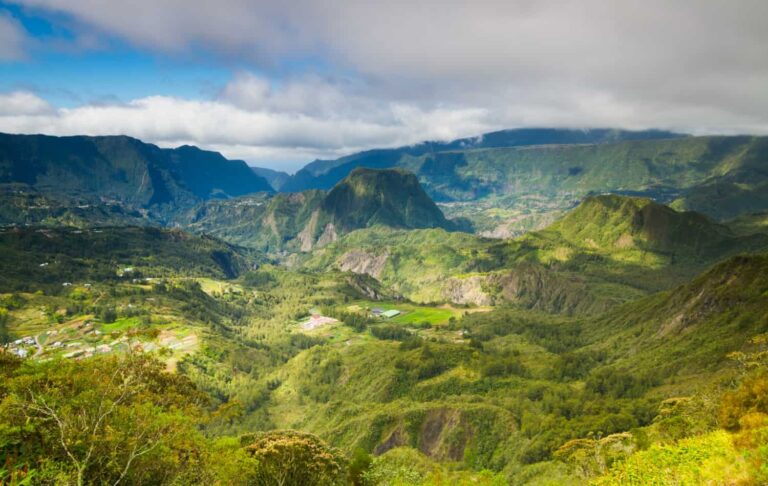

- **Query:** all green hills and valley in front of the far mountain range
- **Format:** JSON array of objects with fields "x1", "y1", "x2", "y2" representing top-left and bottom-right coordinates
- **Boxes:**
[{"x1": 0, "y1": 151, "x2": 768, "y2": 485}]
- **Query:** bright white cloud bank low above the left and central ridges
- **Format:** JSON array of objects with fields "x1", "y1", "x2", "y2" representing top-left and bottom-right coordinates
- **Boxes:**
[{"x1": 0, "y1": 84, "x2": 488, "y2": 170}]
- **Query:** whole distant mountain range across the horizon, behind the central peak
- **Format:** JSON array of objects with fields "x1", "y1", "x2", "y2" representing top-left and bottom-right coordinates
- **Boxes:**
[{"x1": 6, "y1": 129, "x2": 768, "y2": 243}]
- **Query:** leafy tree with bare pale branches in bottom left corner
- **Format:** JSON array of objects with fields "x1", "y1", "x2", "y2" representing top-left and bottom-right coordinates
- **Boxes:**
[{"x1": 0, "y1": 355, "x2": 210, "y2": 485}]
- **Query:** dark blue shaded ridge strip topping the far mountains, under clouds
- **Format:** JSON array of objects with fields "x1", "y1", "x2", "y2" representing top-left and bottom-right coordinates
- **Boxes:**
[{"x1": 283, "y1": 128, "x2": 685, "y2": 192}]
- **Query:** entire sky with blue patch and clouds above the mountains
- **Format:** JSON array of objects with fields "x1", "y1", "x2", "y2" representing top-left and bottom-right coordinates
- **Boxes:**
[{"x1": 0, "y1": 0, "x2": 768, "y2": 172}]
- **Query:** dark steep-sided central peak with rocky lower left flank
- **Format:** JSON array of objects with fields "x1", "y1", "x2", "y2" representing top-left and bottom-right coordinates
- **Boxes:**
[{"x1": 183, "y1": 169, "x2": 456, "y2": 252}]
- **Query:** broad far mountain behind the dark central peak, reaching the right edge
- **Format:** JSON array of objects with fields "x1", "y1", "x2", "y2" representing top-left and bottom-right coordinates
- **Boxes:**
[{"x1": 283, "y1": 131, "x2": 768, "y2": 237}]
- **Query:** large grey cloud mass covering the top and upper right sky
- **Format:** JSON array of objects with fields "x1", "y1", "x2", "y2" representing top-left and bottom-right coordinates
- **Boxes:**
[{"x1": 7, "y1": 0, "x2": 768, "y2": 139}]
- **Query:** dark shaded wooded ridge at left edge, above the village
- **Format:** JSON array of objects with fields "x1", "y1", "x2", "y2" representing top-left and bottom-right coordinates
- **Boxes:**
[{"x1": 0, "y1": 227, "x2": 259, "y2": 293}]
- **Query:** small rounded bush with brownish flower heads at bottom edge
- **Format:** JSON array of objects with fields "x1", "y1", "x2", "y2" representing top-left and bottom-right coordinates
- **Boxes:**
[{"x1": 243, "y1": 430, "x2": 346, "y2": 486}]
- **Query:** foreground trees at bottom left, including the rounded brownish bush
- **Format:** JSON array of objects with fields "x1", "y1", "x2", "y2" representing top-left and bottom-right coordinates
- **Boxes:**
[{"x1": 0, "y1": 355, "x2": 346, "y2": 485}]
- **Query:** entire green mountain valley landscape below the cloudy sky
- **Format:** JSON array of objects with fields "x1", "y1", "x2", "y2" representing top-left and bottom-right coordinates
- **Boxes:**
[{"x1": 0, "y1": 130, "x2": 768, "y2": 485}]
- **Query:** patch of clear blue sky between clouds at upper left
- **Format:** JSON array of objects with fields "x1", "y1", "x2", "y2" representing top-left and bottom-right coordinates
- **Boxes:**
[{"x1": 0, "y1": 2, "x2": 233, "y2": 107}]
